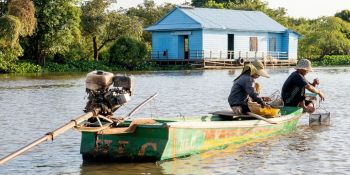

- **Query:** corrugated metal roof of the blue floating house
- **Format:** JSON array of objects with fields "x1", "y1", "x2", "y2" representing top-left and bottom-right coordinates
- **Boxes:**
[{"x1": 146, "y1": 7, "x2": 287, "y2": 32}]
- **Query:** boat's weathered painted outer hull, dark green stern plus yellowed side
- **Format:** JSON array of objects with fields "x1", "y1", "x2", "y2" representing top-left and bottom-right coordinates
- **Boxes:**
[{"x1": 81, "y1": 106, "x2": 302, "y2": 161}]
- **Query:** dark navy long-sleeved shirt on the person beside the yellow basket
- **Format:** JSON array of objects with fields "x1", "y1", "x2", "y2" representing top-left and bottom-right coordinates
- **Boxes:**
[{"x1": 228, "y1": 74, "x2": 263, "y2": 107}]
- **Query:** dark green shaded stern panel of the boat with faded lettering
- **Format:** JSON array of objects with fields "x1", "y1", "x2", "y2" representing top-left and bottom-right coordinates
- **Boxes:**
[{"x1": 80, "y1": 126, "x2": 168, "y2": 161}]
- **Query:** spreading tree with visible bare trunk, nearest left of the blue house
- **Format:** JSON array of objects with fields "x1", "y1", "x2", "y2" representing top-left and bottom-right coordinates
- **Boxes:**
[{"x1": 81, "y1": 0, "x2": 142, "y2": 60}]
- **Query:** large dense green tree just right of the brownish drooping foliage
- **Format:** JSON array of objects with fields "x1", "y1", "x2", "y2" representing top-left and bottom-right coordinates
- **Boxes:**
[{"x1": 23, "y1": 0, "x2": 80, "y2": 65}]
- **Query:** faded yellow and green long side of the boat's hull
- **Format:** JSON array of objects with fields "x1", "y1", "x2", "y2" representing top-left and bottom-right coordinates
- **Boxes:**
[{"x1": 161, "y1": 116, "x2": 298, "y2": 160}]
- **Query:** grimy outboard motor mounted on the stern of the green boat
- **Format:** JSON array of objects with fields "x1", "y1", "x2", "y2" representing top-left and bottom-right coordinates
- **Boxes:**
[{"x1": 84, "y1": 71, "x2": 134, "y2": 116}]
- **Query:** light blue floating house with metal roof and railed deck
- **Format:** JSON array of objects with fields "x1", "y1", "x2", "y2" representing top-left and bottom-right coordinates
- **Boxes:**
[{"x1": 146, "y1": 6, "x2": 300, "y2": 60}]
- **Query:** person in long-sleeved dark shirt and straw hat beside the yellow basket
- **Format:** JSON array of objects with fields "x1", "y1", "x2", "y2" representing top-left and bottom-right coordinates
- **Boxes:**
[{"x1": 228, "y1": 60, "x2": 269, "y2": 115}]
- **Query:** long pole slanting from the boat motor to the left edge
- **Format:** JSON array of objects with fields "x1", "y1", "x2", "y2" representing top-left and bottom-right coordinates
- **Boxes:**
[{"x1": 0, "y1": 108, "x2": 101, "y2": 165}]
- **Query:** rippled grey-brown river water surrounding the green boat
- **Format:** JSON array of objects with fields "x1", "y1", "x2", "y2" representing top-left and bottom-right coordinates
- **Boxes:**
[{"x1": 0, "y1": 67, "x2": 350, "y2": 175}]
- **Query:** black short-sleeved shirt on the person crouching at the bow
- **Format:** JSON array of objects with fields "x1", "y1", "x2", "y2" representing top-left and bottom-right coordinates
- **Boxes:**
[{"x1": 282, "y1": 71, "x2": 309, "y2": 106}]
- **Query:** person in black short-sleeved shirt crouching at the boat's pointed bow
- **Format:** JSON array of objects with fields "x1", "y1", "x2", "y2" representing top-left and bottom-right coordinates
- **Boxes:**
[{"x1": 282, "y1": 59, "x2": 325, "y2": 113}]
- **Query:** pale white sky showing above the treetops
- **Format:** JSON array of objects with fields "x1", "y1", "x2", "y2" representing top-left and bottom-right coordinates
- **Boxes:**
[{"x1": 113, "y1": 0, "x2": 350, "y2": 18}]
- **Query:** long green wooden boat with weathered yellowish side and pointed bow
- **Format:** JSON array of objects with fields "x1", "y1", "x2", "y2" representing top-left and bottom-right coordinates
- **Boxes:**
[{"x1": 80, "y1": 107, "x2": 302, "y2": 162}]
